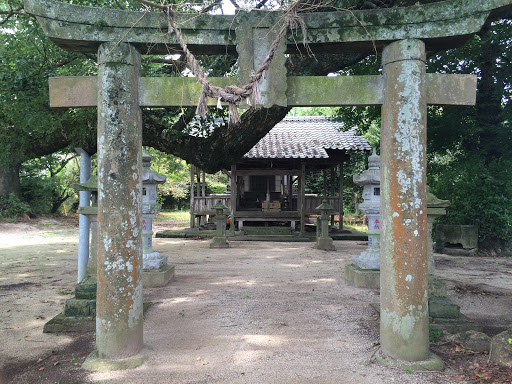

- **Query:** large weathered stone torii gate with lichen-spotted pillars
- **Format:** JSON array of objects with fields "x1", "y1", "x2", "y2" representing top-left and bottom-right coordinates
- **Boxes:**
[{"x1": 25, "y1": 0, "x2": 512, "y2": 369}]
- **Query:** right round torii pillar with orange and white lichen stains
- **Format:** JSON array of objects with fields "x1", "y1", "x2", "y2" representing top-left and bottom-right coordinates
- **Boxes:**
[{"x1": 380, "y1": 39, "x2": 442, "y2": 369}]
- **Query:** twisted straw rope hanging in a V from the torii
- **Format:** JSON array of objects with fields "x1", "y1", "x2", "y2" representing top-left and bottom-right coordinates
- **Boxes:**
[{"x1": 138, "y1": 0, "x2": 306, "y2": 124}]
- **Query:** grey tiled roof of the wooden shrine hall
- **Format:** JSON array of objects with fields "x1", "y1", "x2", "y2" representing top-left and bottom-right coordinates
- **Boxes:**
[{"x1": 244, "y1": 117, "x2": 371, "y2": 159}]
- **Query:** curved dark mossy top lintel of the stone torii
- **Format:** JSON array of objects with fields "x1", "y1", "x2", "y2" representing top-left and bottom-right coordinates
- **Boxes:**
[{"x1": 25, "y1": 0, "x2": 512, "y2": 54}]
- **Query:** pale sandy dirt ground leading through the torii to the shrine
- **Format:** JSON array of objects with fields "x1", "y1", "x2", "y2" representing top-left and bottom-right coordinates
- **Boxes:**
[{"x1": 0, "y1": 221, "x2": 512, "y2": 384}]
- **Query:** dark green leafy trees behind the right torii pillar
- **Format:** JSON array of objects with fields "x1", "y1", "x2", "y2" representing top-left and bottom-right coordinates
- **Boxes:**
[{"x1": 338, "y1": 14, "x2": 512, "y2": 249}]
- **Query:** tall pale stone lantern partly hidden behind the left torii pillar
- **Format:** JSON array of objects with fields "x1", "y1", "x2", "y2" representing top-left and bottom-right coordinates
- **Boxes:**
[{"x1": 142, "y1": 151, "x2": 174, "y2": 287}]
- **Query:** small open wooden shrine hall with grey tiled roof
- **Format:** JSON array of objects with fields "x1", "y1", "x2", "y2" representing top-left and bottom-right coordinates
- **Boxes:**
[{"x1": 190, "y1": 117, "x2": 371, "y2": 232}]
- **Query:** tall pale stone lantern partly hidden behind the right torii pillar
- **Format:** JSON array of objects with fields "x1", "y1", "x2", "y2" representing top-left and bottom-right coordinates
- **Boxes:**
[{"x1": 353, "y1": 148, "x2": 380, "y2": 269}]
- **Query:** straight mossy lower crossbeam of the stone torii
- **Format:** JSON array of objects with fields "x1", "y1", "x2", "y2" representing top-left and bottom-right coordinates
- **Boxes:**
[{"x1": 49, "y1": 73, "x2": 476, "y2": 108}]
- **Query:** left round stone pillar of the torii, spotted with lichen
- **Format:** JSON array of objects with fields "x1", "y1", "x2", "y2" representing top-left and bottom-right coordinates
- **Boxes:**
[{"x1": 84, "y1": 42, "x2": 143, "y2": 370}]
